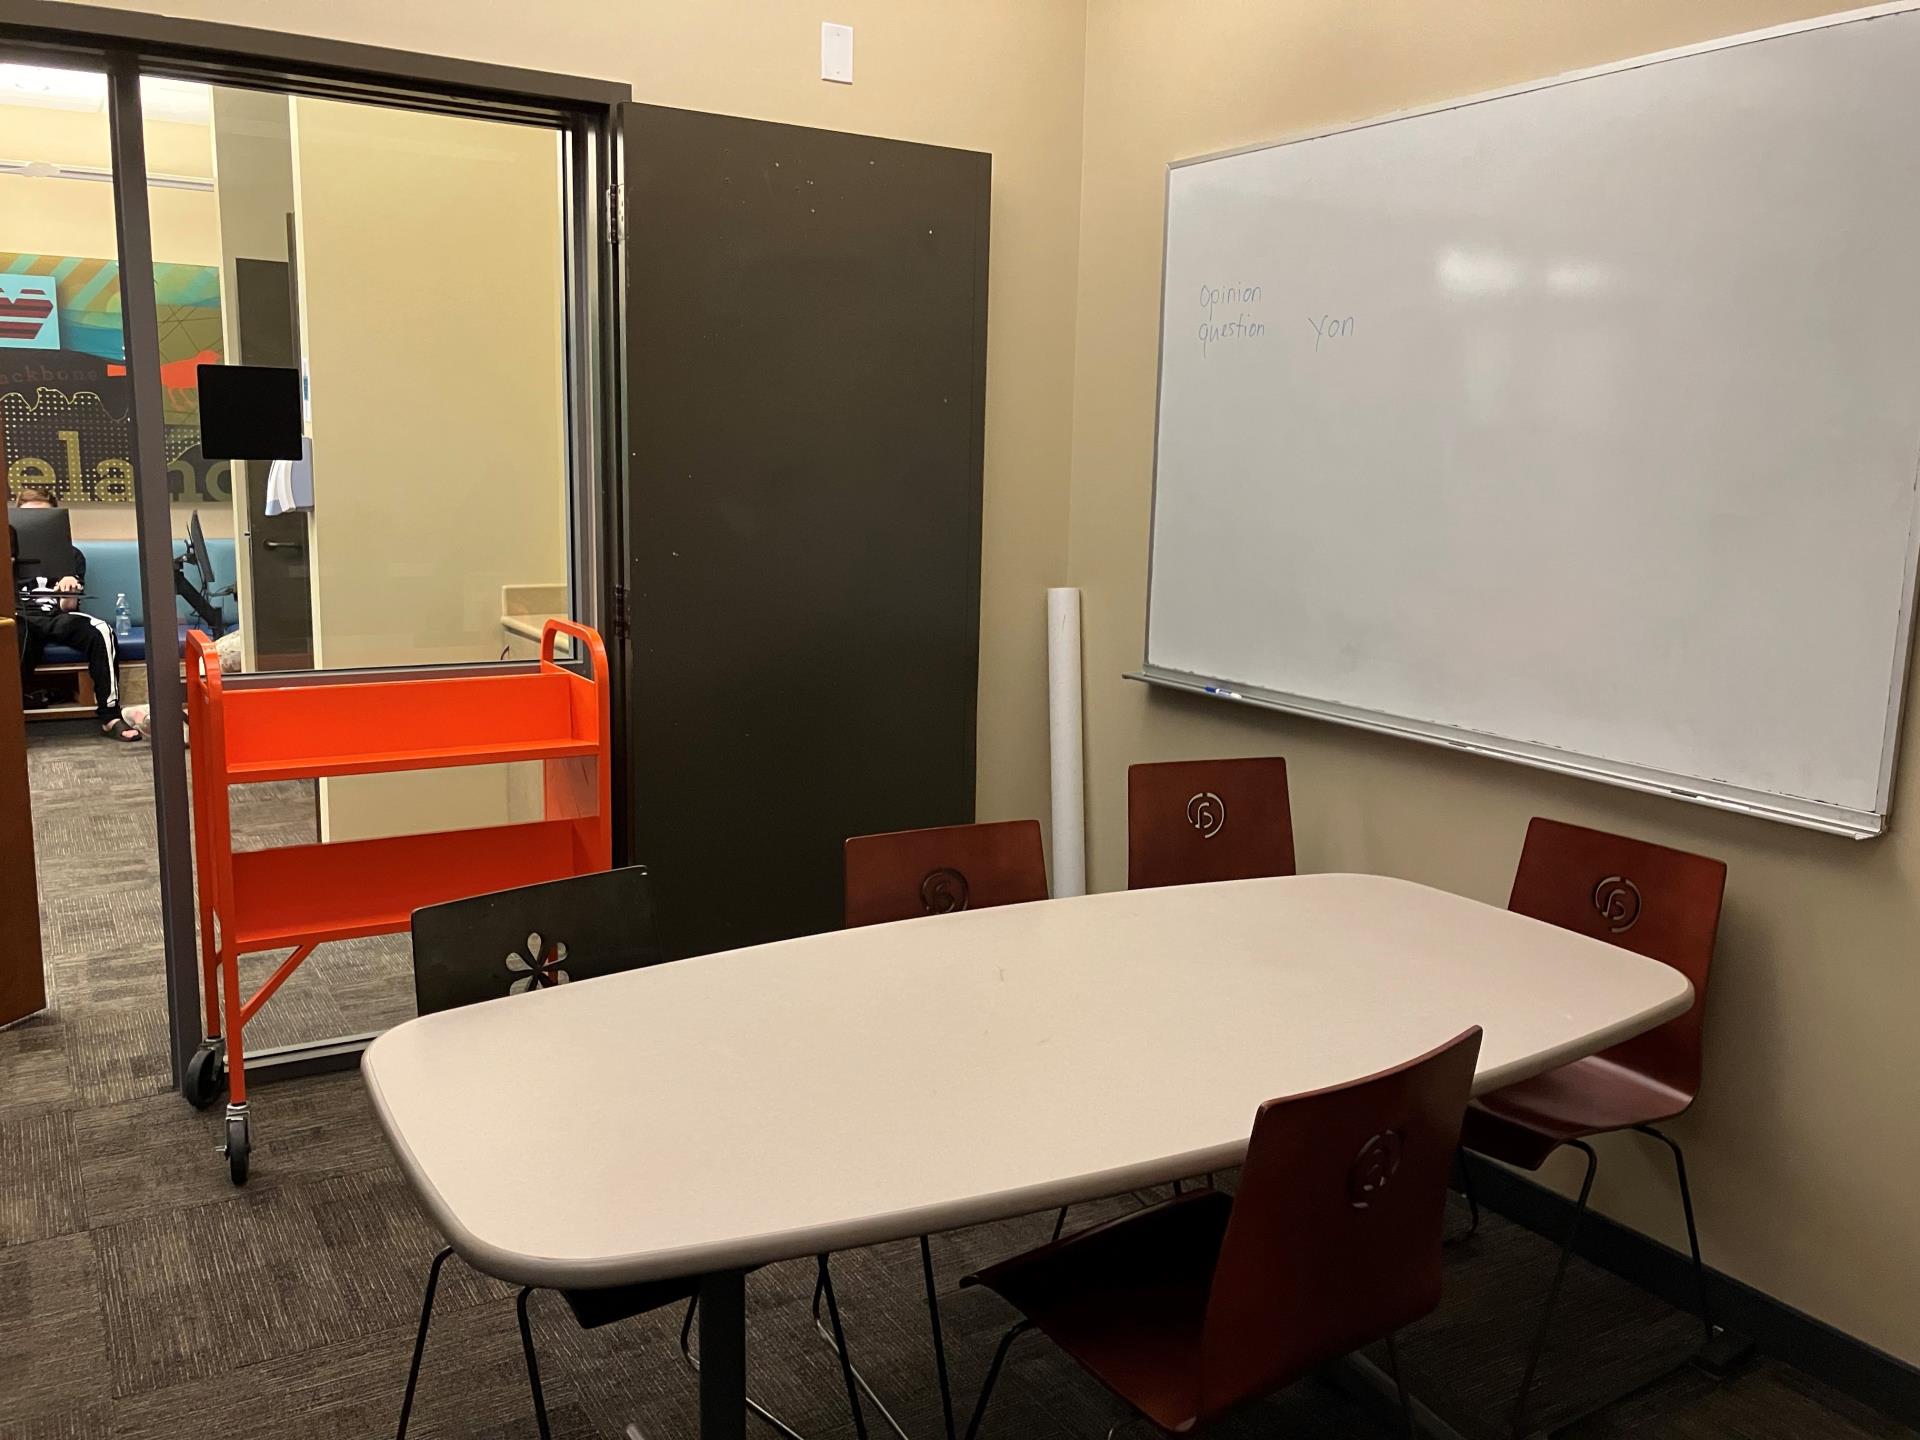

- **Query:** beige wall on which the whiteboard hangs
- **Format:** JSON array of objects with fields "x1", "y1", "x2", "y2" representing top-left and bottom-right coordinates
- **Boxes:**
[{"x1": 1069, "y1": 0, "x2": 1920, "y2": 1361}]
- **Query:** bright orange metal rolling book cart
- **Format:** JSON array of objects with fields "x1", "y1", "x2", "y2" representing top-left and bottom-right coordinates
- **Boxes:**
[{"x1": 186, "y1": 620, "x2": 612, "y2": 1185}]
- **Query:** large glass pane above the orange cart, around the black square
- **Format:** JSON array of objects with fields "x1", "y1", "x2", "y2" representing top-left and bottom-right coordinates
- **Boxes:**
[{"x1": 157, "y1": 81, "x2": 574, "y2": 683}]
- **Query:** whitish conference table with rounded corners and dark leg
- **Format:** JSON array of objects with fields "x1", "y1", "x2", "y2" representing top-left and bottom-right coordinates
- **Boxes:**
[{"x1": 361, "y1": 876, "x2": 1692, "y2": 1440}]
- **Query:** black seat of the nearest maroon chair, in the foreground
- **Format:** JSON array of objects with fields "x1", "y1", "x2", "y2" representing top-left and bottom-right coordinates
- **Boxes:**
[{"x1": 964, "y1": 1190, "x2": 1233, "y2": 1434}]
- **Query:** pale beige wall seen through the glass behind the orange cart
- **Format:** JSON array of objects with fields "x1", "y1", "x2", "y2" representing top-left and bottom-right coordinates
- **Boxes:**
[{"x1": 292, "y1": 100, "x2": 568, "y2": 839}]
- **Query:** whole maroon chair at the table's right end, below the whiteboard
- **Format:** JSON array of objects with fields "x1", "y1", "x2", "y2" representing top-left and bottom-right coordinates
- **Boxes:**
[{"x1": 1461, "y1": 818, "x2": 1726, "y2": 1436}]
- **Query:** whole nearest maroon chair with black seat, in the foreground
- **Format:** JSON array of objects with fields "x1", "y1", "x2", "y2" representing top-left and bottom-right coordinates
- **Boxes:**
[{"x1": 968, "y1": 1027, "x2": 1480, "y2": 1440}]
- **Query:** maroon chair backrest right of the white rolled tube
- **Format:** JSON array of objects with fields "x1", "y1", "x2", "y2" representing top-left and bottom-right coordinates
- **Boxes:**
[{"x1": 1127, "y1": 755, "x2": 1294, "y2": 891}]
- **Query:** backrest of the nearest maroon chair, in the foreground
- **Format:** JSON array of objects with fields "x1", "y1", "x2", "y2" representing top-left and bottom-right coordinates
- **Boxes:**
[{"x1": 1200, "y1": 1025, "x2": 1480, "y2": 1419}]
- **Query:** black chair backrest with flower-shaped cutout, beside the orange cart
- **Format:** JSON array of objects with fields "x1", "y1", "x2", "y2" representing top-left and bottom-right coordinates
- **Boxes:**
[{"x1": 413, "y1": 866, "x2": 666, "y2": 1016}]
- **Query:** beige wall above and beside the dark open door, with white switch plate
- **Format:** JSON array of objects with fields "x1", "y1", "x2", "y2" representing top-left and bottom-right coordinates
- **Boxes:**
[{"x1": 90, "y1": 0, "x2": 1085, "y2": 844}]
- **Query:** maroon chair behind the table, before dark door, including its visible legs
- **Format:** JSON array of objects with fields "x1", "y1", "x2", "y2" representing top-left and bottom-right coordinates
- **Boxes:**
[{"x1": 814, "y1": 820, "x2": 1066, "y2": 1440}]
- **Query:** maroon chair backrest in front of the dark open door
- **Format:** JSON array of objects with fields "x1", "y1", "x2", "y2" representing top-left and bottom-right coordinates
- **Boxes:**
[{"x1": 847, "y1": 820, "x2": 1046, "y2": 925}]
